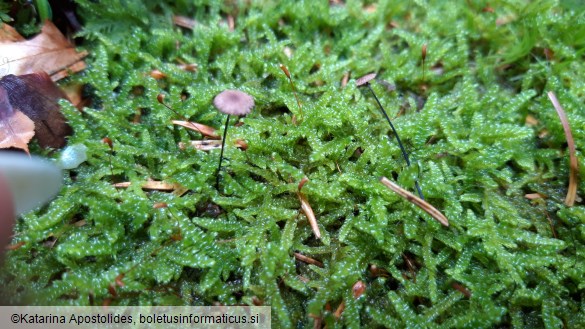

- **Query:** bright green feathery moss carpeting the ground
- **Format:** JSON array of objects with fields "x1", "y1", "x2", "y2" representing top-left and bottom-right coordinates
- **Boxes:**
[{"x1": 2, "y1": 0, "x2": 585, "y2": 328}]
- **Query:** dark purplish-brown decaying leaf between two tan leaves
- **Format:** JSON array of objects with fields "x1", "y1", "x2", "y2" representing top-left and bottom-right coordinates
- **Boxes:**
[{"x1": 0, "y1": 72, "x2": 71, "y2": 148}]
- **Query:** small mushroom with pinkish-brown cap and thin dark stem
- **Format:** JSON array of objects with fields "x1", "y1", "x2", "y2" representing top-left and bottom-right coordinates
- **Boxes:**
[{"x1": 213, "y1": 89, "x2": 254, "y2": 189}]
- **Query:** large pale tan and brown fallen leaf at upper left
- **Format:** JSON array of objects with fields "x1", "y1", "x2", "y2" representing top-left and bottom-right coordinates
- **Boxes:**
[{"x1": 0, "y1": 21, "x2": 87, "y2": 81}]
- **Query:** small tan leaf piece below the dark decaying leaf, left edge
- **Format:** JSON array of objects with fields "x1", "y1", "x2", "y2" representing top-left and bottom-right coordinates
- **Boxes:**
[{"x1": 0, "y1": 88, "x2": 35, "y2": 153}]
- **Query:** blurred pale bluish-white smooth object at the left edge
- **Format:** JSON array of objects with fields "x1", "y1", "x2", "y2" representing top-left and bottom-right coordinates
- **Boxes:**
[{"x1": 0, "y1": 152, "x2": 62, "y2": 216}]
